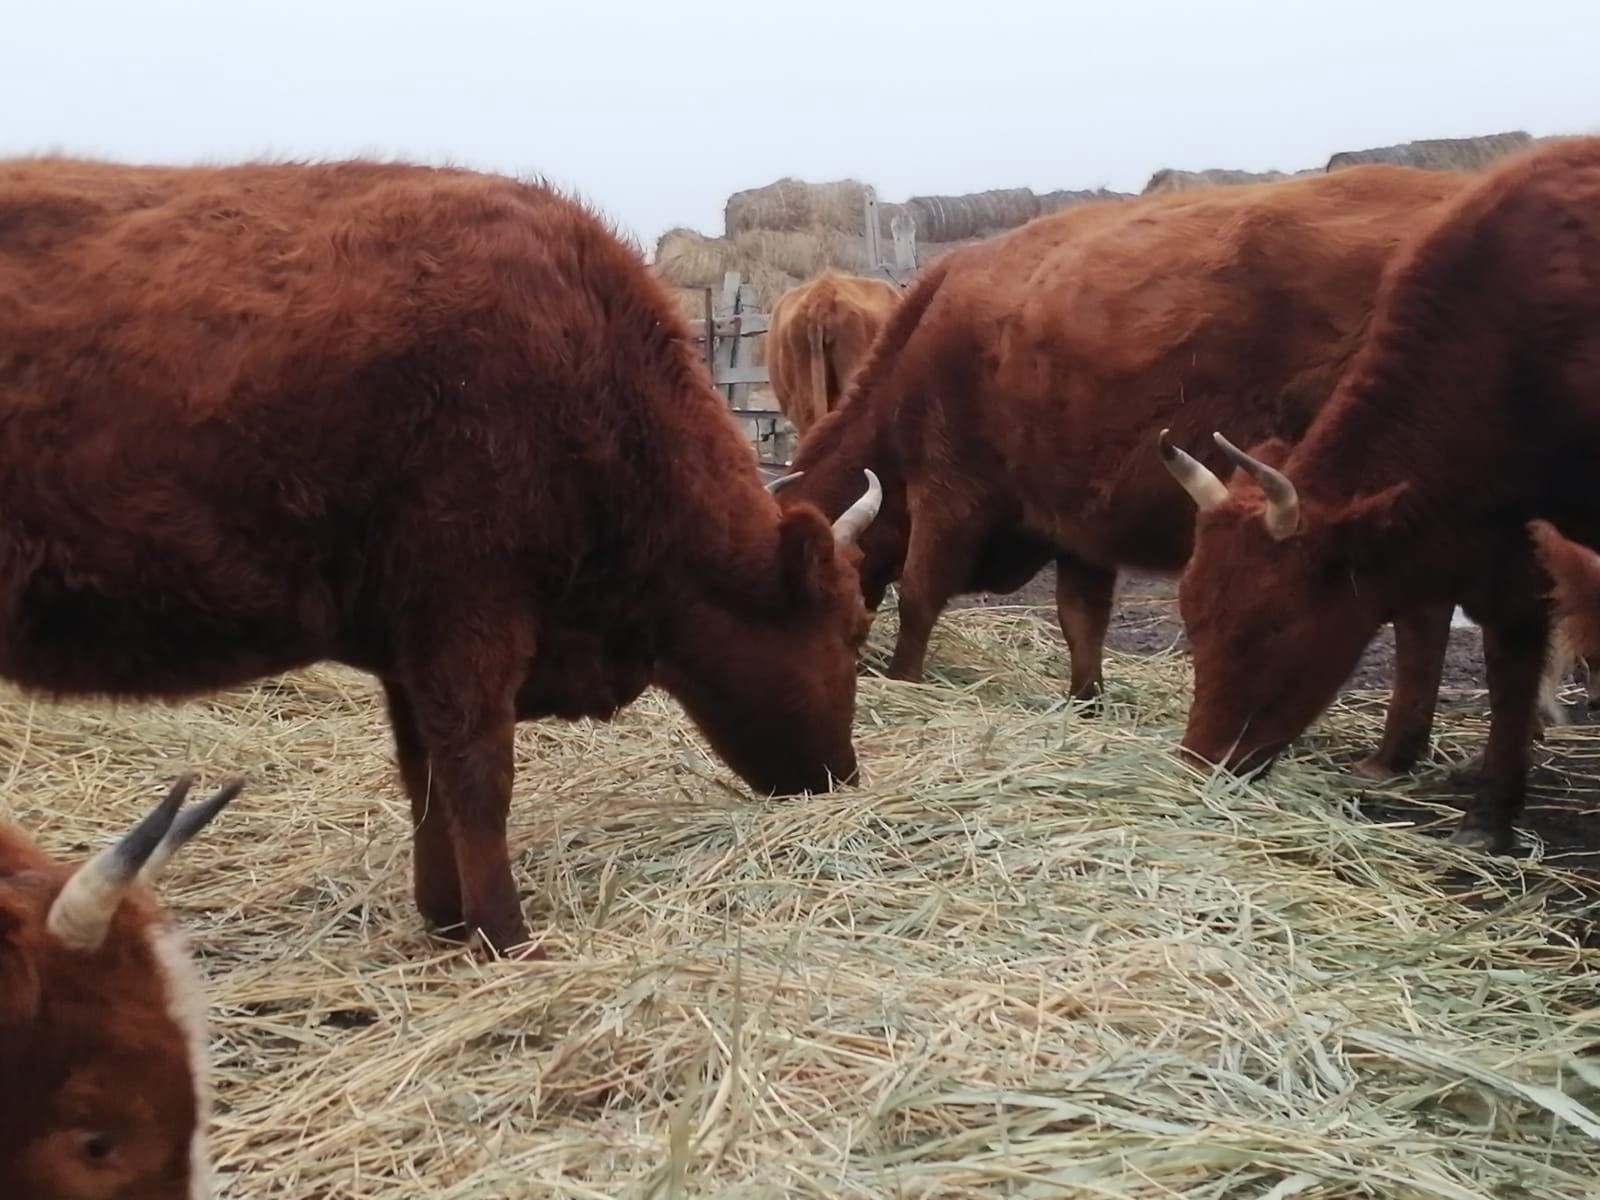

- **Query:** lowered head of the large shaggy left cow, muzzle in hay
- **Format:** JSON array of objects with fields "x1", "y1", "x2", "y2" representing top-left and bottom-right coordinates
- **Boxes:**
[{"x1": 658, "y1": 470, "x2": 883, "y2": 795}]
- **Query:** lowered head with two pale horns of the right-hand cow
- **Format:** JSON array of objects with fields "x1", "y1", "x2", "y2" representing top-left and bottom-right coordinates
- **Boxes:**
[{"x1": 1160, "y1": 429, "x2": 1397, "y2": 771}]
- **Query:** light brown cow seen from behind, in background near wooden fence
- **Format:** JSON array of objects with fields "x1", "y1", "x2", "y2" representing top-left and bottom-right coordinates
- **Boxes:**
[{"x1": 766, "y1": 270, "x2": 901, "y2": 437}]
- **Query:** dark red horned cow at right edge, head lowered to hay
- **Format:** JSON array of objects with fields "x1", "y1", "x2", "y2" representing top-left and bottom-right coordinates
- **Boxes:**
[{"x1": 1152, "y1": 139, "x2": 1600, "y2": 850}]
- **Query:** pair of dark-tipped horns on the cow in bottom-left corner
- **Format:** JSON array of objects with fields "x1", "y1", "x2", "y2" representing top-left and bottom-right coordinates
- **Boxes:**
[{"x1": 45, "y1": 774, "x2": 243, "y2": 952}]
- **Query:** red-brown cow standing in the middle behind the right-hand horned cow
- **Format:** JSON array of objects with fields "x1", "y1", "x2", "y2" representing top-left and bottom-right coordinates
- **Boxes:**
[{"x1": 782, "y1": 166, "x2": 1467, "y2": 774}]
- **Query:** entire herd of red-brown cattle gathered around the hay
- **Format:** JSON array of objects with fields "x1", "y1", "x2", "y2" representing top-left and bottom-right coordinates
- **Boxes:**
[{"x1": 0, "y1": 139, "x2": 1600, "y2": 1200}]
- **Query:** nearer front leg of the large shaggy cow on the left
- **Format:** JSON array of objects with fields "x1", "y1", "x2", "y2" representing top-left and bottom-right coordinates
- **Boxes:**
[{"x1": 406, "y1": 637, "x2": 531, "y2": 955}]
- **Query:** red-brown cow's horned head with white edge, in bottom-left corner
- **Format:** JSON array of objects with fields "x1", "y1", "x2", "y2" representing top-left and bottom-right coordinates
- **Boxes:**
[{"x1": 0, "y1": 776, "x2": 243, "y2": 1200}]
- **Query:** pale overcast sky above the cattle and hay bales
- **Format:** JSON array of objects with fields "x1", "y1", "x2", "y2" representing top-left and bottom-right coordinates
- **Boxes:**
[{"x1": 0, "y1": 0, "x2": 1600, "y2": 256}]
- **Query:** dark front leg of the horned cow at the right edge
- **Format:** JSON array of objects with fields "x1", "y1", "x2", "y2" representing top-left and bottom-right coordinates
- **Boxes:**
[{"x1": 1450, "y1": 619, "x2": 1546, "y2": 853}]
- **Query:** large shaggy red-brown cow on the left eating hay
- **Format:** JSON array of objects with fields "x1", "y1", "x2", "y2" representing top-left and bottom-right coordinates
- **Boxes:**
[{"x1": 0, "y1": 158, "x2": 877, "y2": 950}]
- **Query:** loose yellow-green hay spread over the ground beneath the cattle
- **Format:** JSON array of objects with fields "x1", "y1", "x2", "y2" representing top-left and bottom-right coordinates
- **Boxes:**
[{"x1": 9, "y1": 611, "x2": 1600, "y2": 1200}]
